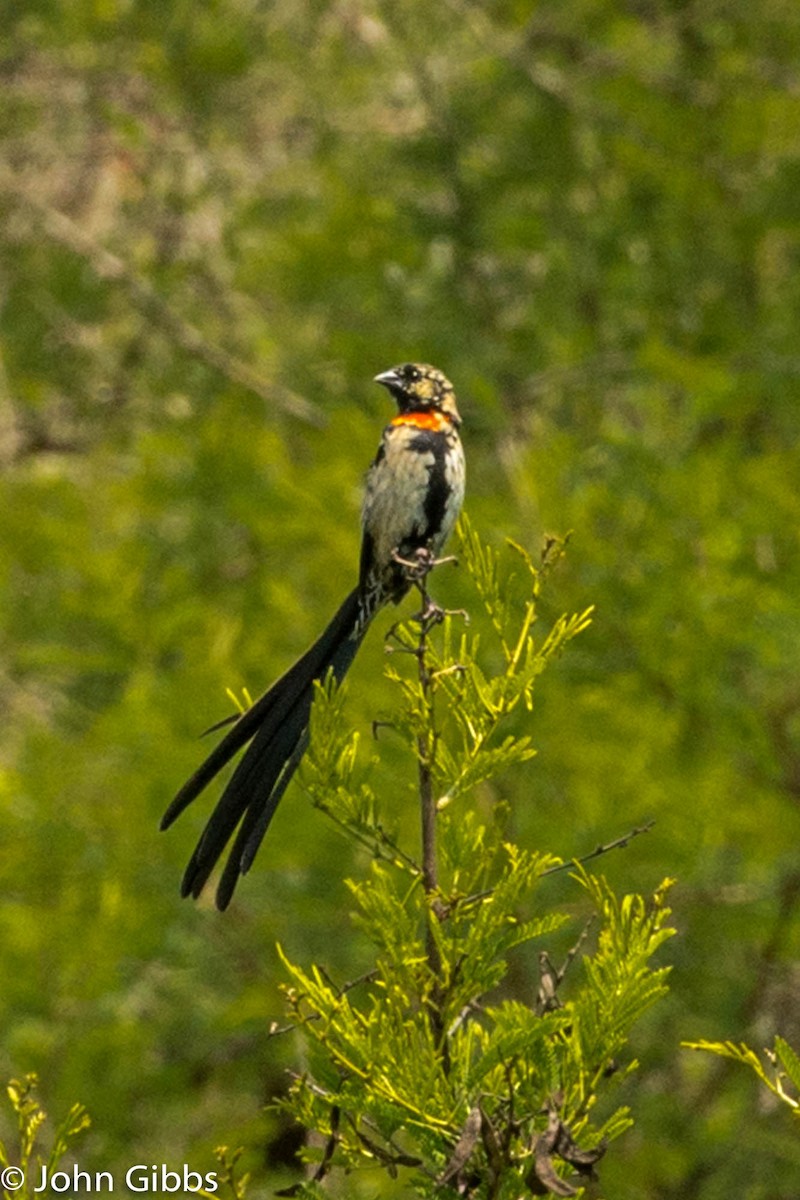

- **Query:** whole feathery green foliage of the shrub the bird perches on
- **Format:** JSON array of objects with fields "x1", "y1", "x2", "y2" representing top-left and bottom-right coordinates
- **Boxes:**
[{"x1": 281, "y1": 542, "x2": 673, "y2": 1198}]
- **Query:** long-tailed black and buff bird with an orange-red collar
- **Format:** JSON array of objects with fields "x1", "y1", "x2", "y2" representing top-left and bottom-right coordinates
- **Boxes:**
[{"x1": 161, "y1": 362, "x2": 465, "y2": 911}]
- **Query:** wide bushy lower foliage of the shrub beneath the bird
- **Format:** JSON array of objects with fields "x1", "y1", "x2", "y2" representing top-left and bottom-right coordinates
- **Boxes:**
[{"x1": 282, "y1": 844, "x2": 672, "y2": 1196}]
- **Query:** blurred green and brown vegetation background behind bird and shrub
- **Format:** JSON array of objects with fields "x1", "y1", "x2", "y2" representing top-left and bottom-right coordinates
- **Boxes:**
[{"x1": 0, "y1": 0, "x2": 800, "y2": 1200}]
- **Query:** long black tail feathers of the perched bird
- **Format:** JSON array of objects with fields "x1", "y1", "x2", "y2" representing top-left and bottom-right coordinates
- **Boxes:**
[{"x1": 161, "y1": 588, "x2": 368, "y2": 908}]
